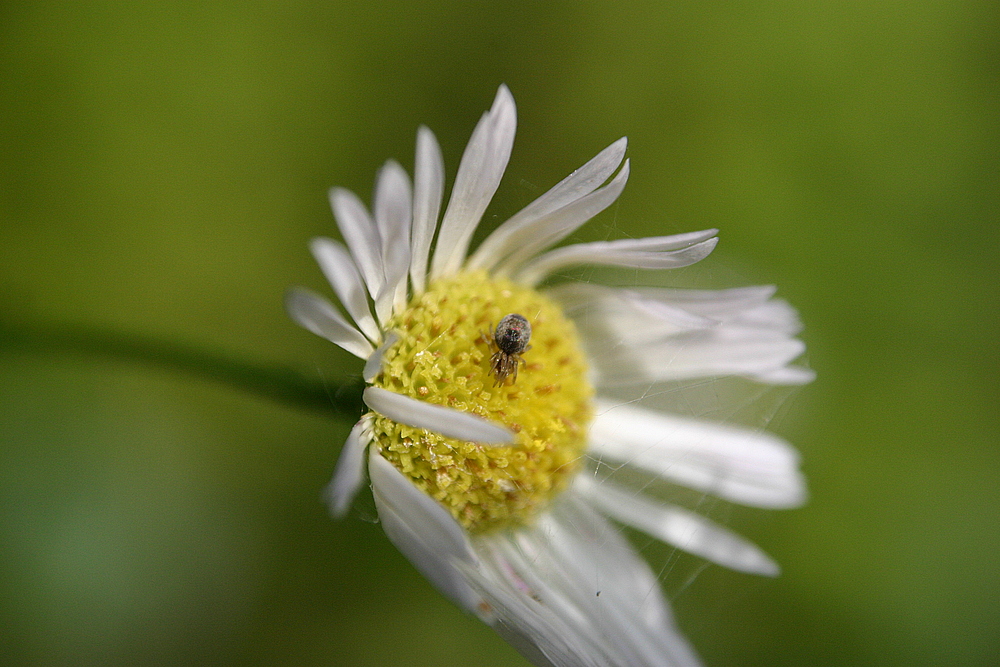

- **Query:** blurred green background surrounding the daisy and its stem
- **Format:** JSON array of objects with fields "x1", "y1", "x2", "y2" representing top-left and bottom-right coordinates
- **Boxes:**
[{"x1": 0, "y1": 0, "x2": 1000, "y2": 667}]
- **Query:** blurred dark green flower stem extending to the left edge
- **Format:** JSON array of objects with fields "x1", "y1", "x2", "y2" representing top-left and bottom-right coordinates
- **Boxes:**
[{"x1": 0, "y1": 317, "x2": 364, "y2": 419}]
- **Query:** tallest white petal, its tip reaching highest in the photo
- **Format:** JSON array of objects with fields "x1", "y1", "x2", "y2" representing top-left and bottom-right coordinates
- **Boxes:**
[{"x1": 431, "y1": 86, "x2": 517, "y2": 278}]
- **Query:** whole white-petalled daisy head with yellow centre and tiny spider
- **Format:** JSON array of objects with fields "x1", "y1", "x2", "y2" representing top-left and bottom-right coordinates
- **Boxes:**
[{"x1": 286, "y1": 86, "x2": 812, "y2": 667}]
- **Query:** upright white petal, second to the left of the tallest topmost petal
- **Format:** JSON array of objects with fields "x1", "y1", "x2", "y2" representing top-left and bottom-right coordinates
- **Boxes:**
[{"x1": 374, "y1": 160, "x2": 413, "y2": 324}]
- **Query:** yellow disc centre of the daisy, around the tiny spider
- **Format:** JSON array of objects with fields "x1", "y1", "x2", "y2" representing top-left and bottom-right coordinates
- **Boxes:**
[{"x1": 372, "y1": 272, "x2": 593, "y2": 533}]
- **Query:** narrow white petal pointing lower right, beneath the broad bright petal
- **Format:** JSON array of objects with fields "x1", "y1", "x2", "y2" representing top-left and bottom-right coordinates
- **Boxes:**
[{"x1": 576, "y1": 475, "x2": 780, "y2": 577}]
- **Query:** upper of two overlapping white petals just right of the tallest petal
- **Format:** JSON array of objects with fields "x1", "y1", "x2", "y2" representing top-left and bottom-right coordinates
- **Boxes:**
[{"x1": 469, "y1": 137, "x2": 628, "y2": 270}]
